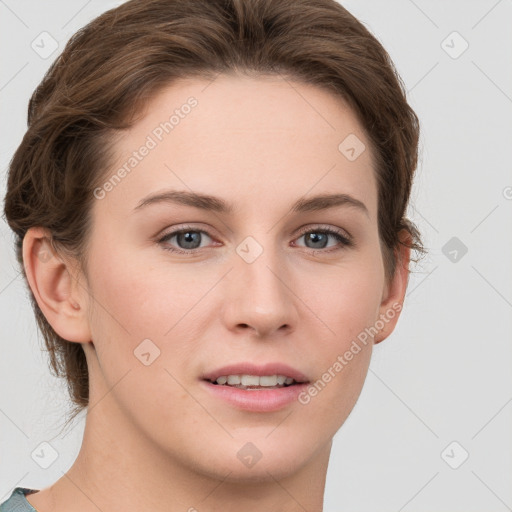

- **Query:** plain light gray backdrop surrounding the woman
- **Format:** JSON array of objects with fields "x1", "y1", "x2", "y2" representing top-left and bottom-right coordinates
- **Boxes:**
[{"x1": 0, "y1": 0, "x2": 512, "y2": 512}]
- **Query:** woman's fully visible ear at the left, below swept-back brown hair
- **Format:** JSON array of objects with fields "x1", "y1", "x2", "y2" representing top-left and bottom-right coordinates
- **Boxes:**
[{"x1": 23, "y1": 227, "x2": 91, "y2": 343}]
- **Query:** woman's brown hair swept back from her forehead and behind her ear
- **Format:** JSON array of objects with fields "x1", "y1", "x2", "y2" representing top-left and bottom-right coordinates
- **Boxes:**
[{"x1": 5, "y1": 0, "x2": 425, "y2": 426}]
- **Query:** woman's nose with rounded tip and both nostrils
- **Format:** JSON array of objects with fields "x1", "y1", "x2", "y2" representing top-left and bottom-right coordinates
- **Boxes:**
[{"x1": 222, "y1": 243, "x2": 299, "y2": 338}]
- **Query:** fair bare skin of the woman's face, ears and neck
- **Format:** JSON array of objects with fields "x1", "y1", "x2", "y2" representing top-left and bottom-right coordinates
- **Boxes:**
[{"x1": 23, "y1": 75, "x2": 409, "y2": 512}]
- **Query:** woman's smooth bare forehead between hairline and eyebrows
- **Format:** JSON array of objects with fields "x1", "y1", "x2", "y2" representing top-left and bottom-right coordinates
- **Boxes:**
[{"x1": 96, "y1": 75, "x2": 376, "y2": 220}]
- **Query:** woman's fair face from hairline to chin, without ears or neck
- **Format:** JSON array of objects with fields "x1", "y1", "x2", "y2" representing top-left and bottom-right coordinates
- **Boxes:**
[{"x1": 69, "y1": 75, "x2": 404, "y2": 479}]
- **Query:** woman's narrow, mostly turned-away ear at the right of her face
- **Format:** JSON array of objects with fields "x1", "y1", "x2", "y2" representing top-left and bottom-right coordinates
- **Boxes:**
[{"x1": 374, "y1": 230, "x2": 411, "y2": 345}]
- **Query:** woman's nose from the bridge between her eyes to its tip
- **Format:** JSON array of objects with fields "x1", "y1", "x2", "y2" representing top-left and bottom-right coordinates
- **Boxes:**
[{"x1": 226, "y1": 234, "x2": 297, "y2": 335}]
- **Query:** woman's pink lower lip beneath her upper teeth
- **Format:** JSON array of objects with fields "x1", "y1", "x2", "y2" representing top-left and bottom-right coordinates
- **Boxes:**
[{"x1": 202, "y1": 380, "x2": 307, "y2": 412}]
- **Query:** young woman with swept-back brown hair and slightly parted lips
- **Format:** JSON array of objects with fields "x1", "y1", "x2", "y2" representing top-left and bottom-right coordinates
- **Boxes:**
[{"x1": 2, "y1": 0, "x2": 422, "y2": 512}]
